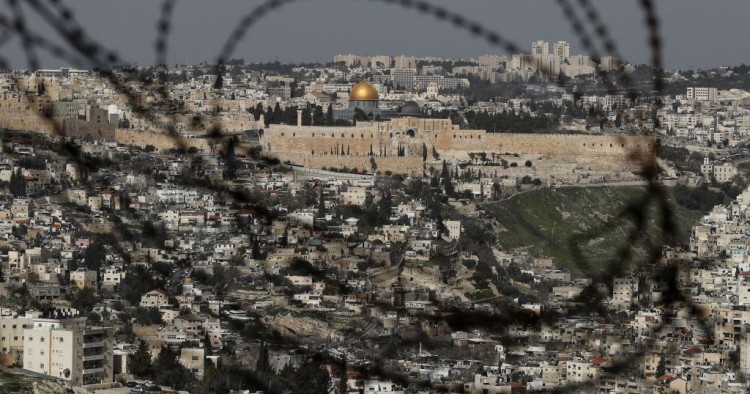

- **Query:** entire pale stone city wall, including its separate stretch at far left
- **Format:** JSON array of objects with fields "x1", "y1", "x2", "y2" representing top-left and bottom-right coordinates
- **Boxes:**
[{"x1": 0, "y1": 107, "x2": 656, "y2": 174}]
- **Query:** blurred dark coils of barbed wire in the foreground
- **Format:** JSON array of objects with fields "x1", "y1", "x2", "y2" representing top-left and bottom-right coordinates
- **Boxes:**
[{"x1": 0, "y1": 0, "x2": 716, "y2": 391}]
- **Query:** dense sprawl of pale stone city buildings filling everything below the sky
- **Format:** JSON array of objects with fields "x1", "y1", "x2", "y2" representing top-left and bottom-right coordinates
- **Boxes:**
[{"x1": 0, "y1": 41, "x2": 750, "y2": 393}]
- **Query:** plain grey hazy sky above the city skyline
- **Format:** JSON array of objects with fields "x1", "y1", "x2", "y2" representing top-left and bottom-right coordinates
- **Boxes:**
[{"x1": 5, "y1": 0, "x2": 750, "y2": 69}]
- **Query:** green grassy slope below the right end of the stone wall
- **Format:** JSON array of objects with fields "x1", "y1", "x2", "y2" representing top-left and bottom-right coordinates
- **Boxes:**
[{"x1": 483, "y1": 186, "x2": 705, "y2": 272}]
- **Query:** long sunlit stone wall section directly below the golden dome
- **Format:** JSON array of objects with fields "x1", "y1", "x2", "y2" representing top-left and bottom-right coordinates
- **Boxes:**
[{"x1": 261, "y1": 118, "x2": 656, "y2": 173}]
